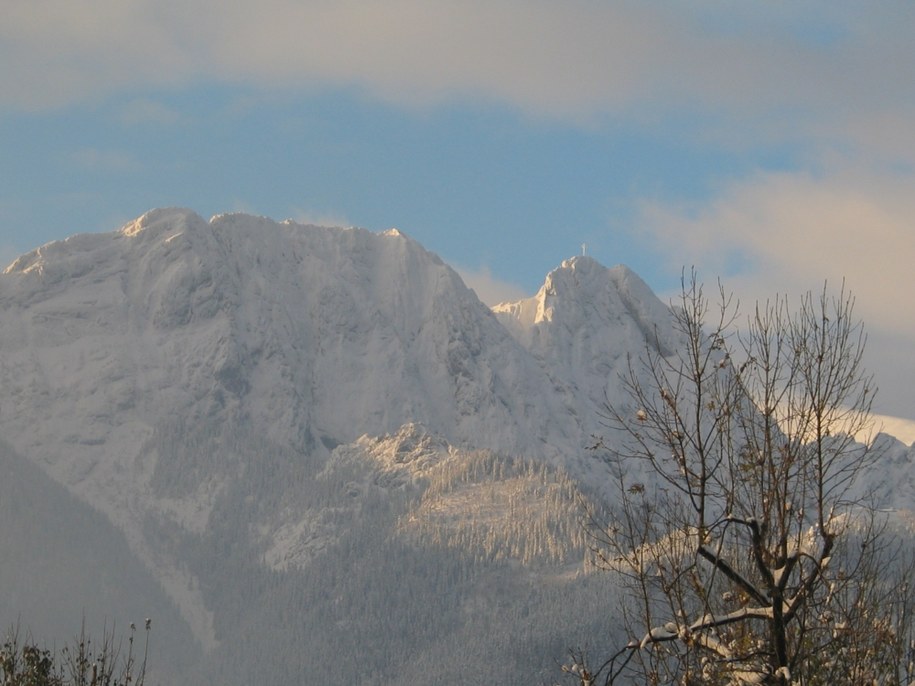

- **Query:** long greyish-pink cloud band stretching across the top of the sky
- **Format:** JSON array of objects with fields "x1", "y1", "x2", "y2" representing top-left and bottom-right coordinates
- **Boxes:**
[{"x1": 0, "y1": 0, "x2": 915, "y2": 146}]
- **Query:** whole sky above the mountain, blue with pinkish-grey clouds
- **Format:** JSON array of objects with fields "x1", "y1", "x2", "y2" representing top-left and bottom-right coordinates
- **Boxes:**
[{"x1": 0, "y1": 0, "x2": 915, "y2": 418}]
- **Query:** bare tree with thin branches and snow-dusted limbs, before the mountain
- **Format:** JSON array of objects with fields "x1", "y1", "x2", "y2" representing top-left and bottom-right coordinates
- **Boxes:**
[{"x1": 564, "y1": 275, "x2": 915, "y2": 685}]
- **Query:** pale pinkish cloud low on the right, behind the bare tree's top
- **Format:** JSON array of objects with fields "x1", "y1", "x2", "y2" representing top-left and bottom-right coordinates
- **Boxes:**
[{"x1": 637, "y1": 164, "x2": 915, "y2": 416}]
